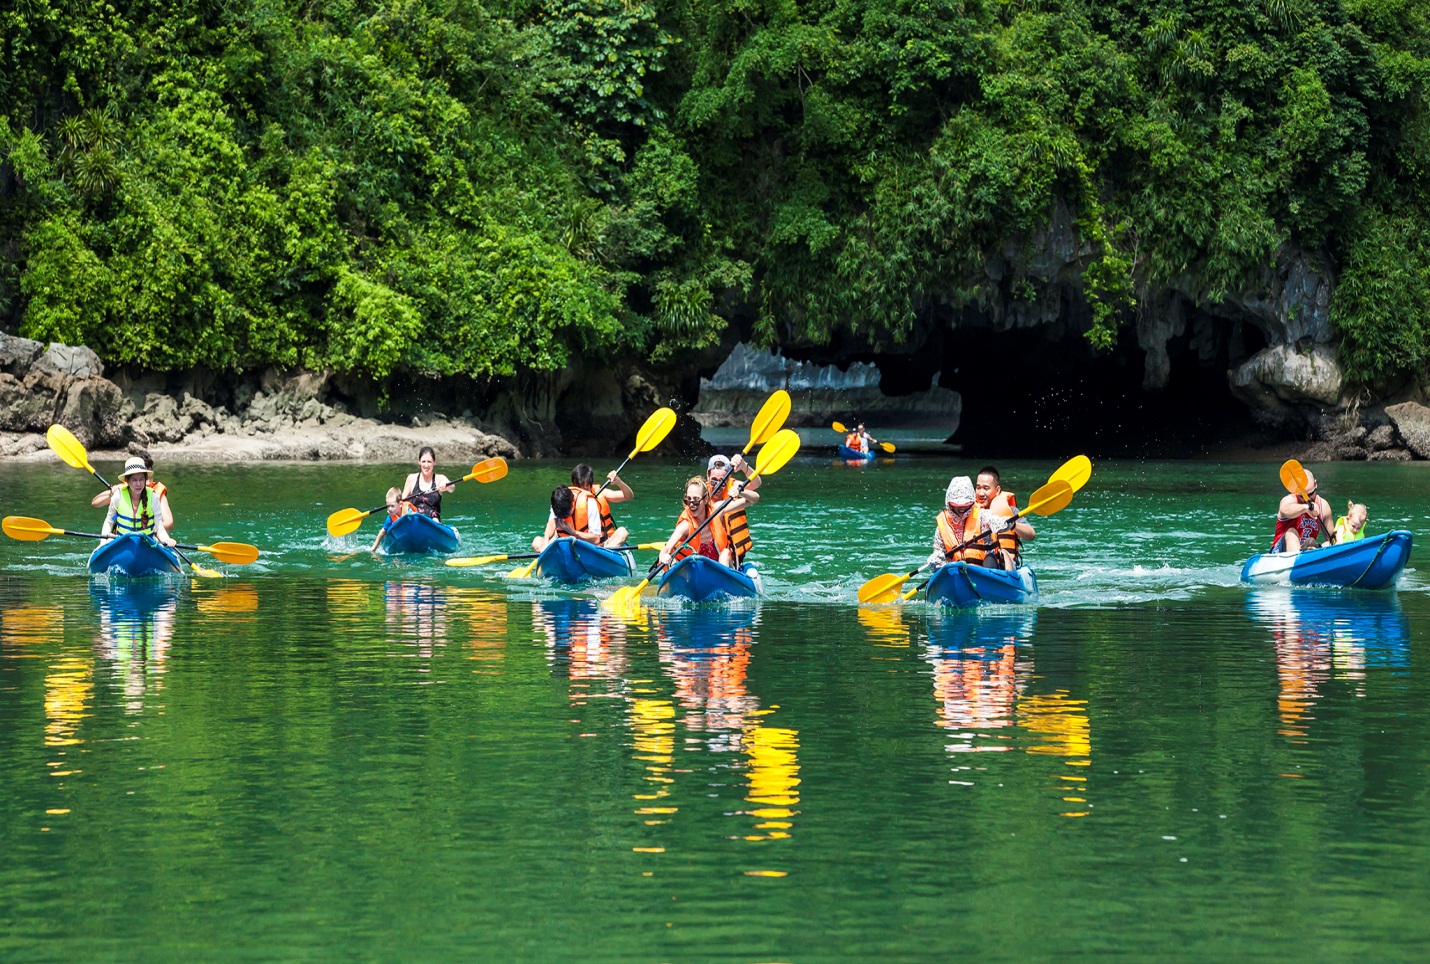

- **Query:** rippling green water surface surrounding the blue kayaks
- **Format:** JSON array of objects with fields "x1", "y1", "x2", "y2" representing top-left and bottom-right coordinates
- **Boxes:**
[{"x1": 0, "y1": 456, "x2": 1430, "y2": 961}]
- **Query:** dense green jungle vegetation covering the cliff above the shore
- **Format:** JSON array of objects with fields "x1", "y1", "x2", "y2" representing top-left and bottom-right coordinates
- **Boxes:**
[{"x1": 0, "y1": 0, "x2": 1430, "y2": 382}]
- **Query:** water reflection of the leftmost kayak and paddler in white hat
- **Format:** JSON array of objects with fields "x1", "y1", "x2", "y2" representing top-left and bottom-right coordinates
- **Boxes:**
[{"x1": 90, "y1": 578, "x2": 182, "y2": 714}]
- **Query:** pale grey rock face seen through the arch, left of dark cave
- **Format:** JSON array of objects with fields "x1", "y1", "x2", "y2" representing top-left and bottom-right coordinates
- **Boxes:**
[{"x1": 691, "y1": 343, "x2": 962, "y2": 433}]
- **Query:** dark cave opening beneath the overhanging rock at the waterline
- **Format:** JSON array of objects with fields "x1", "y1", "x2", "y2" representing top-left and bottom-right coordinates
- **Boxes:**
[{"x1": 879, "y1": 320, "x2": 1278, "y2": 458}]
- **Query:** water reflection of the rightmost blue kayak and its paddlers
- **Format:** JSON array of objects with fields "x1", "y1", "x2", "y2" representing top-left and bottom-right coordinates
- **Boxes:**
[{"x1": 1247, "y1": 588, "x2": 1410, "y2": 744}]
